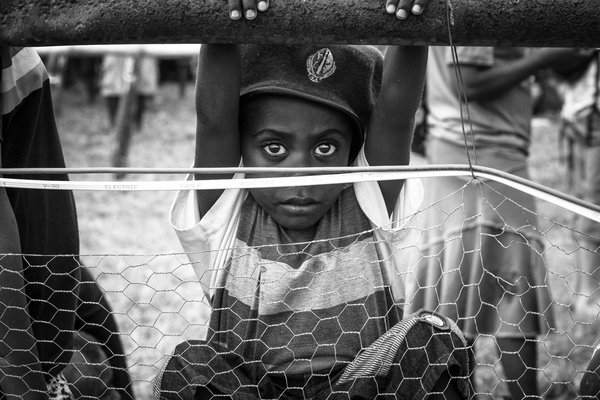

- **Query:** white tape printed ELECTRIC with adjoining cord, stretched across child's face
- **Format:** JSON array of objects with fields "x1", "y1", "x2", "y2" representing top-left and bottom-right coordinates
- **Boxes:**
[{"x1": 0, "y1": 165, "x2": 600, "y2": 222}]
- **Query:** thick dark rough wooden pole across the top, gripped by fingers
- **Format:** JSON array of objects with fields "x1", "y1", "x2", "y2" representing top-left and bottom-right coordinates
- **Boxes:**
[{"x1": 0, "y1": 0, "x2": 600, "y2": 47}]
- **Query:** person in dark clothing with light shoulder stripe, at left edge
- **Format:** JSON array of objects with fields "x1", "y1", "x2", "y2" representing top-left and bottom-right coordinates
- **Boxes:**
[{"x1": 0, "y1": 46, "x2": 80, "y2": 400}]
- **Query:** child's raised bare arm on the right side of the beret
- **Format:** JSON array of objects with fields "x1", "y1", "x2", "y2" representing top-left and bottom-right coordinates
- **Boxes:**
[{"x1": 365, "y1": 46, "x2": 427, "y2": 213}]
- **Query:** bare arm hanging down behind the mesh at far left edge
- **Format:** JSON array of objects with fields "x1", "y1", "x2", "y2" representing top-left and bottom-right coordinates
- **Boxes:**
[{"x1": 0, "y1": 170, "x2": 48, "y2": 400}]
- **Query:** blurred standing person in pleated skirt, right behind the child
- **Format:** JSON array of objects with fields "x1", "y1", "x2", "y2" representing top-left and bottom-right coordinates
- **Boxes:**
[{"x1": 407, "y1": 47, "x2": 580, "y2": 400}]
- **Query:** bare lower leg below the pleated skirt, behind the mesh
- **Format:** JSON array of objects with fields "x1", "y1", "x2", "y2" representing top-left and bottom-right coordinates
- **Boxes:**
[{"x1": 496, "y1": 338, "x2": 539, "y2": 400}]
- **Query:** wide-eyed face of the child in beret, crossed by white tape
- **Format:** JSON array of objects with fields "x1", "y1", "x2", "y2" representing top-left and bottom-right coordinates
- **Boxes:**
[{"x1": 240, "y1": 95, "x2": 354, "y2": 230}]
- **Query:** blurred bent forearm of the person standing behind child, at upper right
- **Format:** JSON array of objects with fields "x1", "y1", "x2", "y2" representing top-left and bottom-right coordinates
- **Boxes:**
[{"x1": 451, "y1": 48, "x2": 578, "y2": 101}]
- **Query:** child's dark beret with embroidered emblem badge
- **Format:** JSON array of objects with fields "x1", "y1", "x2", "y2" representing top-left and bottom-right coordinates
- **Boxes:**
[{"x1": 240, "y1": 44, "x2": 383, "y2": 159}]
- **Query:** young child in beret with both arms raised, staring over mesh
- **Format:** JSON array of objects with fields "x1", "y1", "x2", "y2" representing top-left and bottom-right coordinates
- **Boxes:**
[{"x1": 155, "y1": 3, "x2": 469, "y2": 399}]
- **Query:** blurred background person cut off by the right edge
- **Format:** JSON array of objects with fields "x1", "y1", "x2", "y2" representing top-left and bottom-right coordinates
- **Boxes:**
[{"x1": 553, "y1": 49, "x2": 600, "y2": 322}]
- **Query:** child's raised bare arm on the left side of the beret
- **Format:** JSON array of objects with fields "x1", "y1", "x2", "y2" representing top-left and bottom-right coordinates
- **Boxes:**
[{"x1": 194, "y1": 44, "x2": 241, "y2": 215}]
